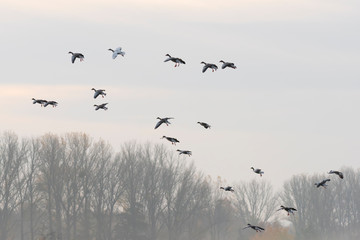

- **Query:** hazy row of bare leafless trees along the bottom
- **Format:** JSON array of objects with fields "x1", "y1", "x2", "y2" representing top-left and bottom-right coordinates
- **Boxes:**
[{"x1": 0, "y1": 132, "x2": 360, "y2": 240}]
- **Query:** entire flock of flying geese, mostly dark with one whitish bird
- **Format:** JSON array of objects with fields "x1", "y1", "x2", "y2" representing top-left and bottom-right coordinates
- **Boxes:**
[{"x1": 32, "y1": 47, "x2": 344, "y2": 232}]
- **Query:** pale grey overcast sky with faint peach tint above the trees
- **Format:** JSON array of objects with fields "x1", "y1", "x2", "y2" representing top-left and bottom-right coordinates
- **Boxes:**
[{"x1": 0, "y1": 0, "x2": 360, "y2": 187}]
